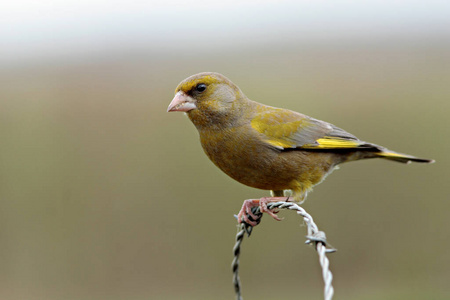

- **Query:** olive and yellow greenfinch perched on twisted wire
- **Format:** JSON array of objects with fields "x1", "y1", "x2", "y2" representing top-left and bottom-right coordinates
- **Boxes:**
[{"x1": 167, "y1": 72, "x2": 434, "y2": 226}]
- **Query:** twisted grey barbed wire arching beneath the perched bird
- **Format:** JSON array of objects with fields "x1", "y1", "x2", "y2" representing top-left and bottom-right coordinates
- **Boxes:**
[{"x1": 231, "y1": 201, "x2": 336, "y2": 300}]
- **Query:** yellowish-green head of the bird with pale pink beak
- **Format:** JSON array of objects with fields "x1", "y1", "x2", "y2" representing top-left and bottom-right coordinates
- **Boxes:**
[{"x1": 167, "y1": 72, "x2": 245, "y2": 128}]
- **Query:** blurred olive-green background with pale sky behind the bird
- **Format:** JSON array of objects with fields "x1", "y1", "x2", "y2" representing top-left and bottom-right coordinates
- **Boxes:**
[{"x1": 0, "y1": 0, "x2": 450, "y2": 300}]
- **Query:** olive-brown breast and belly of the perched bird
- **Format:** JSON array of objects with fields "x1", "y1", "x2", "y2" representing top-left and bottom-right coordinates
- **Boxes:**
[{"x1": 200, "y1": 128, "x2": 332, "y2": 190}]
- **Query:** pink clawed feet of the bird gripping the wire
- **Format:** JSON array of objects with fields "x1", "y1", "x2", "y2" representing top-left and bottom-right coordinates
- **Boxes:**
[{"x1": 237, "y1": 197, "x2": 286, "y2": 226}]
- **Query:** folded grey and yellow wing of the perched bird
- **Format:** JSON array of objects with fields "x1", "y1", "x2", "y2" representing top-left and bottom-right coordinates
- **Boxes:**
[{"x1": 251, "y1": 107, "x2": 375, "y2": 150}]
